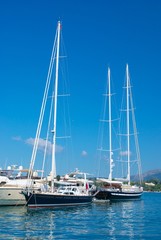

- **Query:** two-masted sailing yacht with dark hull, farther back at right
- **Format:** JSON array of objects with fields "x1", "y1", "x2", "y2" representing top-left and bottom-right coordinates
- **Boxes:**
[{"x1": 95, "y1": 65, "x2": 143, "y2": 201}]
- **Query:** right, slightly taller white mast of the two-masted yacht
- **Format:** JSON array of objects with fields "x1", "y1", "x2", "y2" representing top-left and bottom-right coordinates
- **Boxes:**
[{"x1": 126, "y1": 64, "x2": 130, "y2": 184}]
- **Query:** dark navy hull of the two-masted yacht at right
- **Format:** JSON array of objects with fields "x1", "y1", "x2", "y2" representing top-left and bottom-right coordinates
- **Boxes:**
[{"x1": 95, "y1": 190, "x2": 143, "y2": 201}]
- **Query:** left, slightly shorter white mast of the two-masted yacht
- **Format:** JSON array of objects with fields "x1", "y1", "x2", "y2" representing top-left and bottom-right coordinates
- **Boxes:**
[{"x1": 108, "y1": 68, "x2": 113, "y2": 181}]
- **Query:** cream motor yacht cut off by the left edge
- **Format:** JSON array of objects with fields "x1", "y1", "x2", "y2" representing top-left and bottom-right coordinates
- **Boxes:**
[{"x1": 0, "y1": 165, "x2": 44, "y2": 206}]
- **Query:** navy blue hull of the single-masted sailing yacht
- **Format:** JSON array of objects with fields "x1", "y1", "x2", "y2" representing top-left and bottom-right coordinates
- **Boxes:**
[{"x1": 23, "y1": 193, "x2": 93, "y2": 208}]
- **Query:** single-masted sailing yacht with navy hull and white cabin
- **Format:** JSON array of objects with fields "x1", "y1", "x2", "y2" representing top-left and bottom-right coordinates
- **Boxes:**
[{"x1": 22, "y1": 21, "x2": 93, "y2": 208}]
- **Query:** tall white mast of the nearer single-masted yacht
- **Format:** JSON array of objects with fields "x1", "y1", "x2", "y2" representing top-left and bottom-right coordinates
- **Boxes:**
[{"x1": 52, "y1": 21, "x2": 61, "y2": 191}]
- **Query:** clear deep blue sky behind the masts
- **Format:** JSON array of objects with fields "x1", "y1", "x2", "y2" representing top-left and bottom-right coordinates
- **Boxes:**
[{"x1": 0, "y1": 0, "x2": 161, "y2": 174}]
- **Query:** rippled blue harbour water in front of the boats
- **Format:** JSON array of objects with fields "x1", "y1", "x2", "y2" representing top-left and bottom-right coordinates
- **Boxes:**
[{"x1": 0, "y1": 193, "x2": 161, "y2": 240}]
